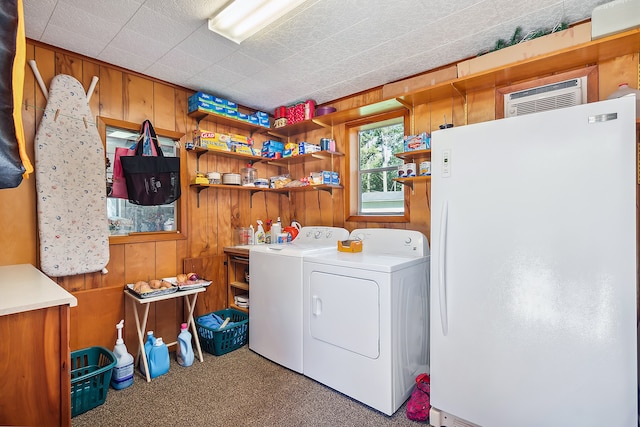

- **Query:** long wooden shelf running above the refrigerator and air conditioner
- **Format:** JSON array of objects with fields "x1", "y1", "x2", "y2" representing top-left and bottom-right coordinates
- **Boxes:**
[{"x1": 396, "y1": 29, "x2": 640, "y2": 107}]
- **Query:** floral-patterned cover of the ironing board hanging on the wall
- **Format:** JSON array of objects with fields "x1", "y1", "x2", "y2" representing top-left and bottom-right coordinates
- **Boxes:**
[{"x1": 35, "y1": 74, "x2": 109, "y2": 277}]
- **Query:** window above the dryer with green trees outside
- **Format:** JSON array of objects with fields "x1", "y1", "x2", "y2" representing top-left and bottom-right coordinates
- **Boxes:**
[{"x1": 349, "y1": 113, "x2": 405, "y2": 221}]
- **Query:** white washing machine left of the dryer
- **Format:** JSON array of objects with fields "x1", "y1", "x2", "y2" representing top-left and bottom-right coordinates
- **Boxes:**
[{"x1": 249, "y1": 226, "x2": 349, "y2": 373}]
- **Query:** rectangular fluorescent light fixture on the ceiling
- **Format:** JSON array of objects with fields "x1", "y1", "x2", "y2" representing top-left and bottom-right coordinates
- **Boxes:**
[{"x1": 209, "y1": 0, "x2": 306, "y2": 44}]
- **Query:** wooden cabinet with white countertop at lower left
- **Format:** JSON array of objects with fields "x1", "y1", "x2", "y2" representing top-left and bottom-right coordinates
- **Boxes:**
[{"x1": 0, "y1": 264, "x2": 77, "y2": 426}]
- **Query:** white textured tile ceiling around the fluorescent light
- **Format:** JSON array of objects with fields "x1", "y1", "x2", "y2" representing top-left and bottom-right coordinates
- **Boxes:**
[{"x1": 24, "y1": 0, "x2": 609, "y2": 113}]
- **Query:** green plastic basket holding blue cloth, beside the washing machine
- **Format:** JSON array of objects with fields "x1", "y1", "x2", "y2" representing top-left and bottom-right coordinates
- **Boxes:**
[{"x1": 196, "y1": 308, "x2": 249, "y2": 356}]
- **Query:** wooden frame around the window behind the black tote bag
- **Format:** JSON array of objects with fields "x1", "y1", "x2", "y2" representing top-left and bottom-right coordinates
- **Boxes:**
[{"x1": 97, "y1": 116, "x2": 188, "y2": 245}]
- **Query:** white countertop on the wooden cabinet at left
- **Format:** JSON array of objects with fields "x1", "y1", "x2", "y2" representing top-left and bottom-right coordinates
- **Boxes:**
[{"x1": 0, "y1": 264, "x2": 78, "y2": 316}]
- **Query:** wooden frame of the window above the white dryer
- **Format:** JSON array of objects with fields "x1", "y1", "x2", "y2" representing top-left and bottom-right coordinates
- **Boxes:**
[{"x1": 345, "y1": 109, "x2": 410, "y2": 223}]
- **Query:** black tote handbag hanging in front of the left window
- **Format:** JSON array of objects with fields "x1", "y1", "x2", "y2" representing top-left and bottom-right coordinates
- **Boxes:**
[{"x1": 120, "y1": 120, "x2": 181, "y2": 206}]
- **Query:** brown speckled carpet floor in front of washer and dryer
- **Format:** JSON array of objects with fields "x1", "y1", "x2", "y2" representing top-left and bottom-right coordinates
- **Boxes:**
[{"x1": 71, "y1": 345, "x2": 428, "y2": 427}]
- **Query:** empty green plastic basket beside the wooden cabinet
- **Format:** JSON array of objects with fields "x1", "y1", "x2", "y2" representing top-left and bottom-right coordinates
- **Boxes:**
[{"x1": 71, "y1": 347, "x2": 116, "y2": 417}]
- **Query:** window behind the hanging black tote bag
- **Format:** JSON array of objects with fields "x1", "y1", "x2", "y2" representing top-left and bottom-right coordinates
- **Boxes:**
[{"x1": 102, "y1": 119, "x2": 180, "y2": 241}]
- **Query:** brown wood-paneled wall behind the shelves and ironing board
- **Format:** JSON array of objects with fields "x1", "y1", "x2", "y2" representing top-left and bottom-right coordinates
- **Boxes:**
[{"x1": 0, "y1": 41, "x2": 638, "y2": 352}]
